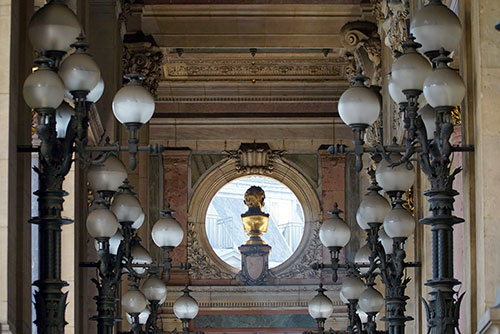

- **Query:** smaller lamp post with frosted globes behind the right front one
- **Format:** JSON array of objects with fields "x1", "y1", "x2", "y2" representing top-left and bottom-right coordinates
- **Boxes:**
[{"x1": 313, "y1": 162, "x2": 419, "y2": 334}]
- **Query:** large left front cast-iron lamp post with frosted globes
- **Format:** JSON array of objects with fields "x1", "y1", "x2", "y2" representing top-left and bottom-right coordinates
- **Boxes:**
[{"x1": 19, "y1": 0, "x2": 161, "y2": 334}]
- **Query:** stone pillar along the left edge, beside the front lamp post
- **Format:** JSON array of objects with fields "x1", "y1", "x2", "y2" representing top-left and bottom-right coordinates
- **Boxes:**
[{"x1": 0, "y1": 0, "x2": 33, "y2": 333}]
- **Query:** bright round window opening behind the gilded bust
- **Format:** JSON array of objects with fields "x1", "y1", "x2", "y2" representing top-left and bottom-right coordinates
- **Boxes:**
[{"x1": 205, "y1": 176, "x2": 304, "y2": 268}]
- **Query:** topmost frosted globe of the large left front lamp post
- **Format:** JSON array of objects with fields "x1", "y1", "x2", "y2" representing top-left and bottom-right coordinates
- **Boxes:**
[{"x1": 28, "y1": 1, "x2": 82, "y2": 52}]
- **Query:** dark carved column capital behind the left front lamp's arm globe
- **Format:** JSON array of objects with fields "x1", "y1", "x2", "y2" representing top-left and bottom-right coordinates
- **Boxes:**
[{"x1": 122, "y1": 42, "x2": 163, "y2": 97}]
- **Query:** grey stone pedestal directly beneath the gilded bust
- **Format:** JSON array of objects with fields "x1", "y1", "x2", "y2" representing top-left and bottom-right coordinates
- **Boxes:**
[{"x1": 238, "y1": 245, "x2": 271, "y2": 285}]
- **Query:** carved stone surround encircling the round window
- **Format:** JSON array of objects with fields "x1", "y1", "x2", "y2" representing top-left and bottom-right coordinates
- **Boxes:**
[{"x1": 188, "y1": 157, "x2": 322, "y2": 279}]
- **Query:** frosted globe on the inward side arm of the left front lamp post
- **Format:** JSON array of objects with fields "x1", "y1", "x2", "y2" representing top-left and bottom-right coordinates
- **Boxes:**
[{"x1": 113, "y1": 80, "x2": 155, "y2": 124}]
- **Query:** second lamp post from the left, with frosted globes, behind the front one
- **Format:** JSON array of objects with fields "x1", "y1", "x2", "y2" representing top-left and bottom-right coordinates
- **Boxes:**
[{"x1": 86, "y1": 159, "x2": 190, "y2": 334}]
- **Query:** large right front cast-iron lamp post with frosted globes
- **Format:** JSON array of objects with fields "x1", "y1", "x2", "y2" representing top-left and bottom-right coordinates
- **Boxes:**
[{"x1": 330, "y1": 0, "x2": 473, "y2": 334}]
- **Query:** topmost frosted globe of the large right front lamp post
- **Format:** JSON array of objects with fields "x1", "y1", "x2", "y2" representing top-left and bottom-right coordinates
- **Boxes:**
[{"x1": 410, "y1": 1, "x2": 462, "y2": 53}]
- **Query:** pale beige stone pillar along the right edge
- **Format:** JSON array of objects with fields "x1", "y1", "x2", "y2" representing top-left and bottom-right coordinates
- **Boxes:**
[{"x1": 464, "y1": 0, "x2": 500, "y2": 324}]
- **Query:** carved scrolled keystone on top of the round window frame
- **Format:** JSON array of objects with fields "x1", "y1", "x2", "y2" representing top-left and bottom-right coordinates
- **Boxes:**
[{"x1": 224, "y1": 143, "x2": 285, "y2": 174}]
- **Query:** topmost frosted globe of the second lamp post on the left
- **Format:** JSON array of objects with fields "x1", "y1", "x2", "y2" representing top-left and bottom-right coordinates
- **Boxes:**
[{"x1": 87, "y1": 154, "x2": 128, "y2": 194}]
